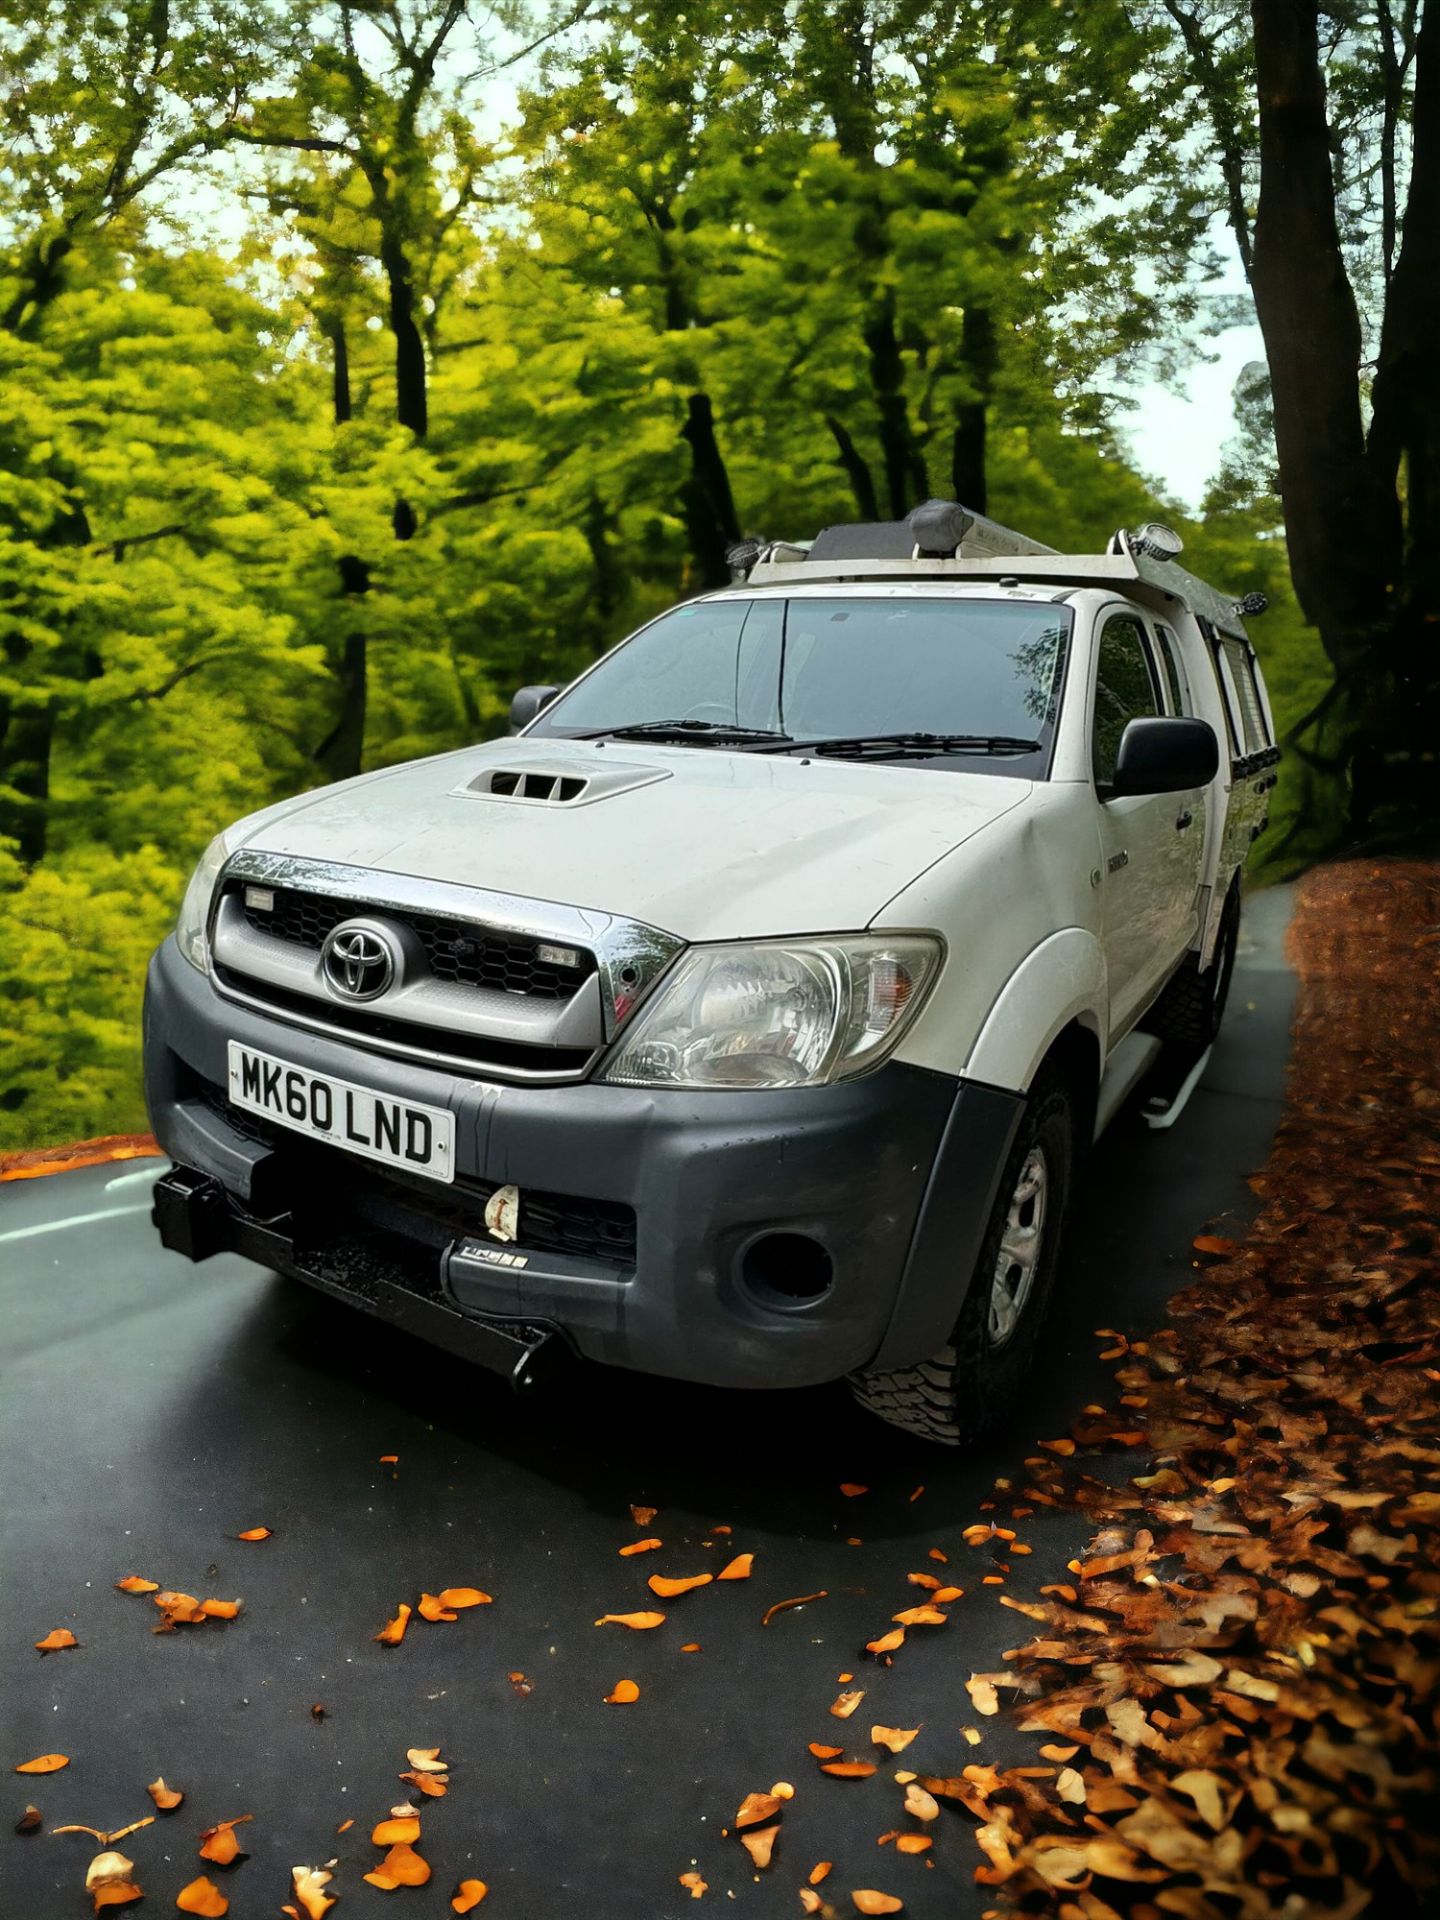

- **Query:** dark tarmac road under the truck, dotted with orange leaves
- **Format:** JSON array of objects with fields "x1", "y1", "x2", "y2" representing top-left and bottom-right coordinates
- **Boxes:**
[{"x1": 0, "y1": 889, "x2": 1292, "y2": 1920}]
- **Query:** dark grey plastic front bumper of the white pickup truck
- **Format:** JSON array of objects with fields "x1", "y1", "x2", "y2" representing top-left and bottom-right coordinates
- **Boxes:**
[{"x1": 146, "y1": 941, "x2": 1021, "y2": 1386}]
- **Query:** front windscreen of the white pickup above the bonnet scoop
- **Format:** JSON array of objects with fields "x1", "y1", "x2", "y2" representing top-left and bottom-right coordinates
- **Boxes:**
[{"x1": 532, "y1": 595, "x2": 1071, "y2": 743}]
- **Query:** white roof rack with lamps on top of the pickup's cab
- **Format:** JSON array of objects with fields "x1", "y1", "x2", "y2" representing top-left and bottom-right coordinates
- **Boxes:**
[{"x1": 726, "y1": 499, "x2": 1265, "y2": 639}]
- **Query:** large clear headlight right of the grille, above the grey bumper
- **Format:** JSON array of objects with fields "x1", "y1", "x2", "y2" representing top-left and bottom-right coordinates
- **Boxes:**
[{"x1": 599, "y1": 933, "x2": 941, "y2": 1089}]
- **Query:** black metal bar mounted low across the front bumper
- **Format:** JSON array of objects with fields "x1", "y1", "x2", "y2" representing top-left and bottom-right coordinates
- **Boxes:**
[{"x1": 150, "y1": 1167, "x2": 568, "y2": 1392}]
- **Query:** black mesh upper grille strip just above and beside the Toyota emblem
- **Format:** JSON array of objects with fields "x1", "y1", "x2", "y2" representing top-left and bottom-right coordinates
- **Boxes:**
[{"x1": 234, "y1": 881, "x2": 595, "y2": 1000}]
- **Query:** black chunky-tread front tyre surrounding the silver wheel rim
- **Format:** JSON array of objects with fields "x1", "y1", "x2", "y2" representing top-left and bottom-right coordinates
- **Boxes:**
[{"x1": 851, "y1": 1068, "x2": 1079, "y2": 1446}]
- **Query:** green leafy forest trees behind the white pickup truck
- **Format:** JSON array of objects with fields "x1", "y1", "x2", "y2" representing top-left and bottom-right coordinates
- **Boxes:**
[{"x1": 0, "y1": 0, "x2": 1440, "y2": 1148}]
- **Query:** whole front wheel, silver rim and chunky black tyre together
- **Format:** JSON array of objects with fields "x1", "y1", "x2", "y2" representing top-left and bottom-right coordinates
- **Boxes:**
[{"x1": 851, "y1": 1069, "x2": 1077, "y2": 1446}]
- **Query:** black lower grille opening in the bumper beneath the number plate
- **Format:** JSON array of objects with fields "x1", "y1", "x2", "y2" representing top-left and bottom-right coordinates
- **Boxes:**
[{"x1": 192, "y1": 1079, "x2": 636, "y2": 1273}]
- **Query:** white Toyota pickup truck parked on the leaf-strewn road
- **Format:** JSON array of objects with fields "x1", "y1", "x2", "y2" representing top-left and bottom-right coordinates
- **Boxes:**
[{"x1": 146, "y1": 501, "x2": 1279, "y2": 1444}]
